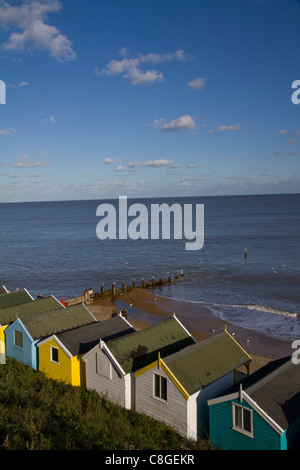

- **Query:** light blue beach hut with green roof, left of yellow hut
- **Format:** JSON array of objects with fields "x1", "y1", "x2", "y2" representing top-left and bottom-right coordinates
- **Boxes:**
[{"x1": 5, "y1": 304, "x2": 97, "y2": 369}]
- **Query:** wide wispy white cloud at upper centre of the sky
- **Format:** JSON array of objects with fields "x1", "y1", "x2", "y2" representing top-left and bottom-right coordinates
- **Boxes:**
[{"x1": 101, "y1": 48, "x2": 188, "y2": 86}]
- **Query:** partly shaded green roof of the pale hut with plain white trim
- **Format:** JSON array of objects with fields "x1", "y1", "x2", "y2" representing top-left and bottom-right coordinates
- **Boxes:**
[{"x1": 105, "y1": 317, "x2": 195, "y2": 373}]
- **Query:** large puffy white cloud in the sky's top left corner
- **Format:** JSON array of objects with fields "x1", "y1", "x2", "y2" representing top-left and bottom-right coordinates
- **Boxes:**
[{"x1": 0, "y1": 0, "x2": 76, "y2": 62}]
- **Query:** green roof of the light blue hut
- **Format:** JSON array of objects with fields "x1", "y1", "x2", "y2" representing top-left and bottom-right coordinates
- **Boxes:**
[{"x1": 22, "y1": 304, "x2": 96, "y2": 340}]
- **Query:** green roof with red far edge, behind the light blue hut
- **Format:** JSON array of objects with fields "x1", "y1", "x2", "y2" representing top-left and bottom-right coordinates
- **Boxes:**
[{"x1": 0, "y1": 295, "x2": 64, "y2": 325}]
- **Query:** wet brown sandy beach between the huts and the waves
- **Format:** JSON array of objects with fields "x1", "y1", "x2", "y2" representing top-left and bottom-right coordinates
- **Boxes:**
[{"x1": 88, "y1": 288, "x2": 293, "y2": 372}]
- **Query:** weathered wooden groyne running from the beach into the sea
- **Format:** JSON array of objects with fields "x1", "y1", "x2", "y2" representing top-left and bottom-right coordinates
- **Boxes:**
[{"x1": 66, "y1": 270, "x2": 184, "y2": 307}]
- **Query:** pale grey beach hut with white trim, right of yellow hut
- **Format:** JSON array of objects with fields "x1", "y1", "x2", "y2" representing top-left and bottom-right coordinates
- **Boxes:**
[{"x1": 82, "y1": 316, "x2": 195, "y2": 409}]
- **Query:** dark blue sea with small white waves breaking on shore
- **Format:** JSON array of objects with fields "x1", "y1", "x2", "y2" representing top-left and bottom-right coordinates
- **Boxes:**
[{"x1": 0, "y1": 194, "x2": 300, "y2": 340}]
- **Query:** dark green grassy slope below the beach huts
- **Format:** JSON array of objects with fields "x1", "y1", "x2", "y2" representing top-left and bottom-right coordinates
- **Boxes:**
[{"x1": 0, "y1": 358, "x2": 211, "y2": 450}]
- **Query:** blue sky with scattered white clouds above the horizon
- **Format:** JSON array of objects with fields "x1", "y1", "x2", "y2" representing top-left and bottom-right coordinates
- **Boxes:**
[{"x1": 0, "y1": 0, "x2": 300, "y2": 202}]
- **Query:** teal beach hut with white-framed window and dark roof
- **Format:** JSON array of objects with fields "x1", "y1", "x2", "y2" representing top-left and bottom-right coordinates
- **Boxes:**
[{"x1": 208, "y1": 357, "x2": 300, "y2": 450}]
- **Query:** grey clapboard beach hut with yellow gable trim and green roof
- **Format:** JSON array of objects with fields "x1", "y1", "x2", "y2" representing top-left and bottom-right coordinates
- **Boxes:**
[{"x1": 134, "y1": 330, "x2": 251, "y2": 440}]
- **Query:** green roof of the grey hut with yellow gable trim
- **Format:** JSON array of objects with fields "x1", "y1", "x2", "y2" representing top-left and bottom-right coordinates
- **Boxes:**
[{"x1": 164, "y1": 331, "x2": 251, "y2": 395}]
